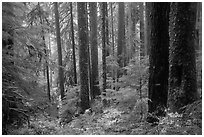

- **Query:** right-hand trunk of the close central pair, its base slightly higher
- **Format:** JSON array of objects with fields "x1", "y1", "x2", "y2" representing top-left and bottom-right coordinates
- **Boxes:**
[{"x1": 90, "y1": 2, "x2": 100, "y2": 99}]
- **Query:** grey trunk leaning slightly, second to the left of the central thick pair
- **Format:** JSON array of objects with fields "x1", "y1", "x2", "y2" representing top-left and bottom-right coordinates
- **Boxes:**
[{"x1": 54, "y1": 2, "x2": 64, "y2": 99}]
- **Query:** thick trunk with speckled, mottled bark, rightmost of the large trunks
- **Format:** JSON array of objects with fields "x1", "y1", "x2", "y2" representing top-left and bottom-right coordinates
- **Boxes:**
[{"x1": 168, "y1": 2, "x2": 198, "y2": 112}]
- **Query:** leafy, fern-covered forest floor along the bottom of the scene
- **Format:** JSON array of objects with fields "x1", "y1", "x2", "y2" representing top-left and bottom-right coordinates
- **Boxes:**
[{"x1": 9, "y1": 89, "x2": 202, "y2": 135}]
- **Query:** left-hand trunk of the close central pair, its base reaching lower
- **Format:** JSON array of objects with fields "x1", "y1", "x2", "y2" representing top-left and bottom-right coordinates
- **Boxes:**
[{"x1": 77, "y1": 2, "x2": 90, "y2": 113}]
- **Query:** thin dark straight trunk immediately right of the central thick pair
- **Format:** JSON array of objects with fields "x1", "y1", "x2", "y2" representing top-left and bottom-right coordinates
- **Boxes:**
[{"x1": 102, "y1": 2, "x2": 107, "y2": 96}]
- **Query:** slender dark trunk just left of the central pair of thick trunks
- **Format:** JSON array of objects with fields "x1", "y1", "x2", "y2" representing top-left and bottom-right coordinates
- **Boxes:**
[{"x1": 70, "y1": 2, "x2": 77, "y2": 85}]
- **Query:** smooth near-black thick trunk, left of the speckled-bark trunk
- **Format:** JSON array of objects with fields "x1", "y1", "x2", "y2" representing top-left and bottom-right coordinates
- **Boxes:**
[{"x1": 148, "y1": 3, "x2": 170, "y2": 116}]
